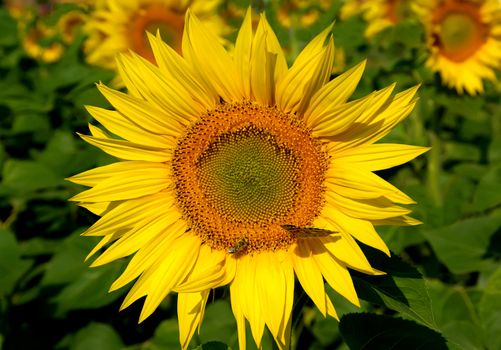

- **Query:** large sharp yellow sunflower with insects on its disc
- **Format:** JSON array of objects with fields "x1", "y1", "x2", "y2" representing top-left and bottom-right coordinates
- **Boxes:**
[{"x1": 66, "y1": 10, "x2": 427, "y2": 349}]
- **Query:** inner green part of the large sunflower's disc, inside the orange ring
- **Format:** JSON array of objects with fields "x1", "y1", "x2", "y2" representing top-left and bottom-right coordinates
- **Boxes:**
[{"x1": 195, "y1": 128, "x2": 298, "y2": 222}]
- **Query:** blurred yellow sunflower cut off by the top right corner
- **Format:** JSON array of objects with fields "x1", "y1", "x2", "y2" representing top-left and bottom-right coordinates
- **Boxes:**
[{"x1": 422, "y1": 0, "x2": 501, "y2": 95}]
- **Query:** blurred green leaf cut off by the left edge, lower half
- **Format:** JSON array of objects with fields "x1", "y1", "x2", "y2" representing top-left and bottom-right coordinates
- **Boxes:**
[{"x1": 0, "y1": 229, "x2": 31, "y2": 299}]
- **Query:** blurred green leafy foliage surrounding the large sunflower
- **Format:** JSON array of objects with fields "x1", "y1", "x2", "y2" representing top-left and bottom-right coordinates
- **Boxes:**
[{"x1": 0, "y1": 1, "x2": 501, "y2": 350}]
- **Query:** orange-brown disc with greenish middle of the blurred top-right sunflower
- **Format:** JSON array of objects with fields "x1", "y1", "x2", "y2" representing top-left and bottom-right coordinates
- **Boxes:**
[{"x1": 434, "y1": 3, "x2": 488, "y2": 62}]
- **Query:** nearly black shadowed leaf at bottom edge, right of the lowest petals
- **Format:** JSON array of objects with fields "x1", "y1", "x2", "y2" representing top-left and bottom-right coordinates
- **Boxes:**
[{"x1": 339, "y1": 314, "x2": 447, "y2": 350}]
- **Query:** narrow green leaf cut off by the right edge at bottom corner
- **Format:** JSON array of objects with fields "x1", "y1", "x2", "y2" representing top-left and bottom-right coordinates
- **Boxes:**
[{"x1": 478, "y1": 267, "x2": 501, "y2": 349}]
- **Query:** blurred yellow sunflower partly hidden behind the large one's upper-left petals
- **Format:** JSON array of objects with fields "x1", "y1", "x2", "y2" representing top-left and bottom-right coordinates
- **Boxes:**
[{"x1": 85, "y1": 0, "x2": 225, "y2": 69}]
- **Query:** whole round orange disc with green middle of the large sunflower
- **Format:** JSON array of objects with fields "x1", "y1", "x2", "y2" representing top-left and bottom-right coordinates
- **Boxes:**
[{"x1": 173, "y1": 102, "x2": 327, "y2": 253}]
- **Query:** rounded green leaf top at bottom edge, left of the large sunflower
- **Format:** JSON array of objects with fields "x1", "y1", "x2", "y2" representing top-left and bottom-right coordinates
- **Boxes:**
[{"x1": 70, "y1": 323, "x2": 124, "y2": 350}]
